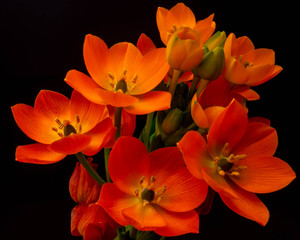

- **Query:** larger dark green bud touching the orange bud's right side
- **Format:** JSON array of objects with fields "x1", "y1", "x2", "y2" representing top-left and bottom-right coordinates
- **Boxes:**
[{"x1": 193, "y1": 47, "x2": 225, "y2": 80}]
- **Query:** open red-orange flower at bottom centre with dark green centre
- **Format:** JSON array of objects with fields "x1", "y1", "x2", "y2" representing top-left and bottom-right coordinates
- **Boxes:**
[{"x1": 99, "y1": 137, "x2": 207, "y2": 236}]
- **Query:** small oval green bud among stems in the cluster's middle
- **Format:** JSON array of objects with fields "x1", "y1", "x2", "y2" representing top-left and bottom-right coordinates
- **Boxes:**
[{"x1": 162, "y1": 108, "x2": 183, "y2": 135}]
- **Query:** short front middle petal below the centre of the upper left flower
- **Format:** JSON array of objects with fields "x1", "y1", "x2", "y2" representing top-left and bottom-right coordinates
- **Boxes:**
[{"x1": 96, "y1": 88, "x2": 138, "y2": 107}]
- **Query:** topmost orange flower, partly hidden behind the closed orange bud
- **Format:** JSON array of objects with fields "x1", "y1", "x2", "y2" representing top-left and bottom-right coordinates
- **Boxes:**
[{"x1": 156, "y1": 3, "x2": 216, "y2": 45}]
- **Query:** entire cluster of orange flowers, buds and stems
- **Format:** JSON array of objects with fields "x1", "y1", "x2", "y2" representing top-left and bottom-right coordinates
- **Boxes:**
[{"x1": 12, "y1": 3, "x2": 295, "y2": 240}]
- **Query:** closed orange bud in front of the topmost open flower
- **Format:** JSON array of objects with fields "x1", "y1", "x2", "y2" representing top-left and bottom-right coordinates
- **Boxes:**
[{"x1": 166, "y1": 27, "x2": 203, "y2": 72}]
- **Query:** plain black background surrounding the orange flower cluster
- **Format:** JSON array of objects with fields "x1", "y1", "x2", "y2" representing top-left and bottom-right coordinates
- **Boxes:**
[{"x1": 0, "y1": 0, "x2": 300, "y2": 240}]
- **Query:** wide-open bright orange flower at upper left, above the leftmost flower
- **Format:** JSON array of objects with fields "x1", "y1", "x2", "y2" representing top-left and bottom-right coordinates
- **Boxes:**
[{"x1": 65, "y1": 34, "x2": 171, "y2": 114}]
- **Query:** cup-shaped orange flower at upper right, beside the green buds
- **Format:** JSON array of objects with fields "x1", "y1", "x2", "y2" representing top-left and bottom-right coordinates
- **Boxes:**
[{"x1": 224, "y1": 33, "x2": 282, "y2": 86}]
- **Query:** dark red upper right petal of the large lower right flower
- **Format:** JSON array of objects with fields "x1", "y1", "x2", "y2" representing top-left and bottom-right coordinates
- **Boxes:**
[{"x1": 232, "y1": 122, "x2": 278, "y2": 157}]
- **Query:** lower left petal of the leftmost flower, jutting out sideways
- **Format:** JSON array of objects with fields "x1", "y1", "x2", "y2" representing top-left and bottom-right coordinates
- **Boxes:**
[{"x1": 16, "y1": 143, "x2": 66, "y2": 164}]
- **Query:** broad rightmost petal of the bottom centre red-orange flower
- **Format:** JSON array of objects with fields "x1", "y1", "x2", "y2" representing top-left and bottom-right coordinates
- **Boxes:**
[{"x1": 158, "y1": 167, "x2": 208, "y2": 212}]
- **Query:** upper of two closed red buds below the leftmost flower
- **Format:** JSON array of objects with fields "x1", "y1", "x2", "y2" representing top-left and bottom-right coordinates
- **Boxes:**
[{"x1": 69, "y1": 158, "x2": 101, "y2": 204}]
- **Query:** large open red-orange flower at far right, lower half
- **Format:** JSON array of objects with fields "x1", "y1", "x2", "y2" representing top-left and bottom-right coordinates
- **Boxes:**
[{"x1": 178, "y1": 100, "x2": 295, "y2": 225}]
